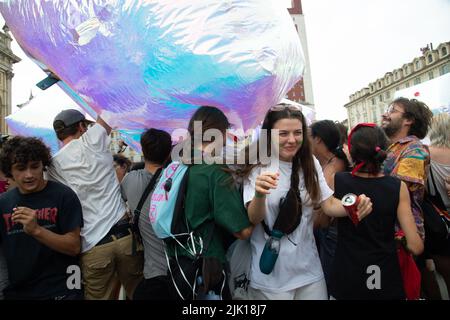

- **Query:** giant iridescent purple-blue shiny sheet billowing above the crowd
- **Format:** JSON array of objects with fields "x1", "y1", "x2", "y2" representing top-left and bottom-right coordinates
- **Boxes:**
[{"x1": 0, "y1": 0, "x2": 304, "y2": 135}]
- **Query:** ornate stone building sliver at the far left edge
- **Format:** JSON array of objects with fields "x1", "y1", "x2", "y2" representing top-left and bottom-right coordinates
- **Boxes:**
[{"x1": 0, "y1": 25, "x2": 20, "y2": 134}]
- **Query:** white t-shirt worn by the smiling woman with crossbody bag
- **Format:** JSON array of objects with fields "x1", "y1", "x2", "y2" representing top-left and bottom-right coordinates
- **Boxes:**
[{"x1": 244, "y1": 158, "x2": 333, "y2": 293}]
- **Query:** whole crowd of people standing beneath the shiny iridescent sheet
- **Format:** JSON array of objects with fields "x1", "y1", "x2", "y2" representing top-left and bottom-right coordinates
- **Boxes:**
[{"x1": 0, "y1": 98, "x2": 450, "y2": 300}]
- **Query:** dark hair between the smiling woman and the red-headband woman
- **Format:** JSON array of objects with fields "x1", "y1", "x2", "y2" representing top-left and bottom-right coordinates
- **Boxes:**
[{"x1": 310, "y1": 120, "x2": 350, "y2": 171}]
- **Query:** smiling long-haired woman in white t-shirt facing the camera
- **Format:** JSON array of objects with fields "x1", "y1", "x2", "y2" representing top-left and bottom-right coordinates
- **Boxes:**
[{"x1": 241, "y1": 104, "x2": 372, "y2": 300}]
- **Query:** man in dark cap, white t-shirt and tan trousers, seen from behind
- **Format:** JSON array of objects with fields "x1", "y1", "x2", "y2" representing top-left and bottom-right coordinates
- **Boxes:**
[{"x1": 48, "y1": 109, "x2": 143, "y2": 299}]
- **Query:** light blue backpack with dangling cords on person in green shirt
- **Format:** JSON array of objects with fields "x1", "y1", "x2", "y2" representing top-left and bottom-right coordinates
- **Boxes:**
[{"x1": 149, "y1": 161, "x2": 218, "y2": 300}]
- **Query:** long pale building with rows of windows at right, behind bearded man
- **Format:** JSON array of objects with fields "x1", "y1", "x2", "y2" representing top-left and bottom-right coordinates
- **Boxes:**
[{"x1": 344, "y1": 42, "x2": 450, "y2": 128}]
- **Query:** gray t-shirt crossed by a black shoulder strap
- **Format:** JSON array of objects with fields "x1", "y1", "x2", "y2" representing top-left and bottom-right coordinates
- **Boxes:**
[{"x1": 120, "y1": 169, "x2": 167, "y2": 279}]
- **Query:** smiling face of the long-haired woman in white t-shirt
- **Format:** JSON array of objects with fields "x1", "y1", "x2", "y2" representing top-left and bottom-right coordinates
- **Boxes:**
[{"x1": 272, "y1": 119, "x2": 303, "y2": 162}]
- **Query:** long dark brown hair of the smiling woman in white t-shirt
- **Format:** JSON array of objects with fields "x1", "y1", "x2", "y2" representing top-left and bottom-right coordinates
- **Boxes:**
[{"x1": 240, "y1": 105, "x2": 320, "y2": 203}]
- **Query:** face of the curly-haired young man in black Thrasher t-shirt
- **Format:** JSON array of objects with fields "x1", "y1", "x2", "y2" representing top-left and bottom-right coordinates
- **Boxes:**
[{"x1": 11, "y1": 161, "x2": 45, "y2": 194}]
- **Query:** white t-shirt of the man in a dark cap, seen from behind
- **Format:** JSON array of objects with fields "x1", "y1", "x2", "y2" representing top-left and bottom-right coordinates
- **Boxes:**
[{"x1": 47, "y1": 124, "x2": 126, "y2": 252}]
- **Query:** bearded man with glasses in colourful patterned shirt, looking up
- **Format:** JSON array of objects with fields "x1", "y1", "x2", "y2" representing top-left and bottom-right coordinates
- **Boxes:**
[{"x1": 381, "y1": 98, "x2": 433, "y2": 239}]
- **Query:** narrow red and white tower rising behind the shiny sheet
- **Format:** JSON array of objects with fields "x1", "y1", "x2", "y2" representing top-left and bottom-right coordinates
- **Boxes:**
[{"x1": 287, "y1": 0, "x2": 314, "y2": 109}]
